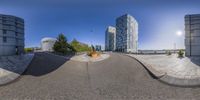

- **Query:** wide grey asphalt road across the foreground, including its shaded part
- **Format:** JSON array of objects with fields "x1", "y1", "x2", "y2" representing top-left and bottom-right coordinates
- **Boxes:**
[{"x1": 0, "y1": 53, "x2": 200, "y2": 100}]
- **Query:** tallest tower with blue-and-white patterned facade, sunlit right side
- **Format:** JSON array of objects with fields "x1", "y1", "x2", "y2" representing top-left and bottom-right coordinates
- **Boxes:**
[{"x1": 116, "y1": 14, "x2": 138, "y2": 53}]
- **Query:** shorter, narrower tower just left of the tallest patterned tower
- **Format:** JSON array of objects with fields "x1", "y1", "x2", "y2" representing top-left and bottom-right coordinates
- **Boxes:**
[{"x1": 105, "y1": 26, "x2": 116, "y2": 51}]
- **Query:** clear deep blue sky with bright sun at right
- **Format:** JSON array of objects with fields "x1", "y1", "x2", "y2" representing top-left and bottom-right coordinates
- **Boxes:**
[{"x1": 0, "y1": 0, "x2": 200, "y2": 50}]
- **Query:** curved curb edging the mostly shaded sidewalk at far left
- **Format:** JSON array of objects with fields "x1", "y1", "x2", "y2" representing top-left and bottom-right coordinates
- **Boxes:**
[{"x1": 0, "y1": 54, "x2": 35, "y2": 86}]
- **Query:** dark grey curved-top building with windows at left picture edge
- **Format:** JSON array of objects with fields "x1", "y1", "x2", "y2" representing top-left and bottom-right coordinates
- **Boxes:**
[{"x1": 0, "y1": 14, "x2": 24, "y2": 56}]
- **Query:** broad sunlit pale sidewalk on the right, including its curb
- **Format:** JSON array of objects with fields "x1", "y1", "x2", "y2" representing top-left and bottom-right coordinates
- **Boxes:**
[{"x1": 127, "y1": 54, "x2": 200, "y2": 86}]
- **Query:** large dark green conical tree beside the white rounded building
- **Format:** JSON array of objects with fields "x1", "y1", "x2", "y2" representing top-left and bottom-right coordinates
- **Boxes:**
[{"x1": 53, "y1": 33, "x2": 70, "y2": 54}]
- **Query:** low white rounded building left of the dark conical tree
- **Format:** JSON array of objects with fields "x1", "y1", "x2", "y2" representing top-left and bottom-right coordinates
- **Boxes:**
[{"x1": 41, "y1": 37, "x2": 56, "y2": 52}]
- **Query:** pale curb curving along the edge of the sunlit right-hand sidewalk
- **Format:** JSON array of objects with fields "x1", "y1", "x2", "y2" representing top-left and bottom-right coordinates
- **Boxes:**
[{"x1": 126, "y1": 54, "x2": 200, "y2": 87}]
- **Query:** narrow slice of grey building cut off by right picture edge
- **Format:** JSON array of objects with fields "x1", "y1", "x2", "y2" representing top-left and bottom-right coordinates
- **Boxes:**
[{"x1": 185, "y1": 14, "x2": 200, "y2": 56}]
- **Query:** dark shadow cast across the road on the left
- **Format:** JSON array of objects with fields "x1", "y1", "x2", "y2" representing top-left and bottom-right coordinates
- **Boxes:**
[{"x1": 22, "y1": 52, "x2": 74, "y2": 76}]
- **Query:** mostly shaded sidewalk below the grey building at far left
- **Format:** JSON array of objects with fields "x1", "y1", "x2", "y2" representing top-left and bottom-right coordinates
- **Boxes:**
[{"x1": 0, "y1": 54, "x2": 34, "y2": 85}]
